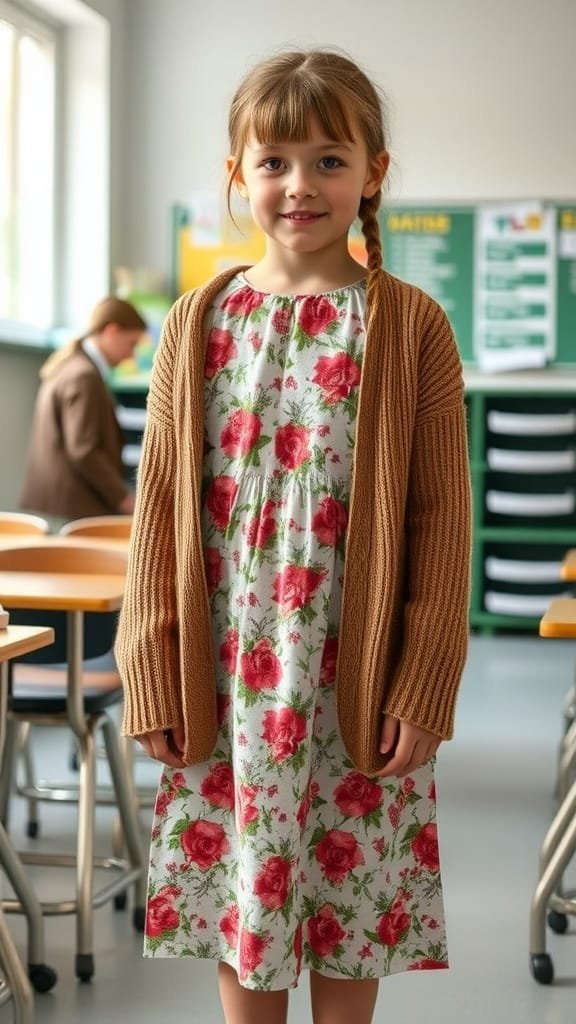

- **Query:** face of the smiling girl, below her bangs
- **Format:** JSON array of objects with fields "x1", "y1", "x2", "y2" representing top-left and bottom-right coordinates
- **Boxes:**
[{"x1": 230, "y1": 119, "x2": 388, "y2": 262}]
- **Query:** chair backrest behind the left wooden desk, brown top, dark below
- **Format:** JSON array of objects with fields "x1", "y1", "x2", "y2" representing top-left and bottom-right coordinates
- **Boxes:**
[{"x1": 0, "y1": 544, "x2": 128, "y2": 665}]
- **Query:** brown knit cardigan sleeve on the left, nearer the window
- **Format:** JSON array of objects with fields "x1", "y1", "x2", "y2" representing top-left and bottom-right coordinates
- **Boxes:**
[{"x1": 115, "y1": 300, "x2": 187, "y2": 735}]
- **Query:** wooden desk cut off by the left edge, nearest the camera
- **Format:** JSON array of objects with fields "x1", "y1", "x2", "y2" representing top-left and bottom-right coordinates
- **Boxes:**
[{"x1": 0, "y1": 626, "x2": 56, "y2": 1024}]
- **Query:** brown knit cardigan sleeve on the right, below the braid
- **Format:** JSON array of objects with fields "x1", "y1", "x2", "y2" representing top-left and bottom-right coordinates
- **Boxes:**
[{"x1": 383, "y1": 303, "x2": 471, "y2": 739}]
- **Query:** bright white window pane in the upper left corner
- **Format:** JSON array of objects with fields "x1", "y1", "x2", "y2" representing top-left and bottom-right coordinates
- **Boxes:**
[{"x1": 0, "y1": 0, "x2": 55, "y2": 331}]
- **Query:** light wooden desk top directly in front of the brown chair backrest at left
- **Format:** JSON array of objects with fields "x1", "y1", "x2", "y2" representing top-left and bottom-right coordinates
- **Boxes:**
[{"x1": 0, "y1": 571, "x2": 126, "y2": 611}]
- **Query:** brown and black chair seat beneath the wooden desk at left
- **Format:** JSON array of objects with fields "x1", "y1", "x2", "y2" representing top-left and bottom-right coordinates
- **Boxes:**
[{"x1": 8, "y1": 655, "x2": 124, "y2": 715}]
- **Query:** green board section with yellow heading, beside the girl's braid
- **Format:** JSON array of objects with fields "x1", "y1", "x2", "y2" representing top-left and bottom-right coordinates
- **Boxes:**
[{"x1": 380, "y1": 206, "x2": 476, "y2": 362}]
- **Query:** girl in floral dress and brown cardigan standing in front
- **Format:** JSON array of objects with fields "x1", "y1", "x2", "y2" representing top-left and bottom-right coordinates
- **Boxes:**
[{"x1": 117, "y1": 51, "x2": 469, "y2": 1024}]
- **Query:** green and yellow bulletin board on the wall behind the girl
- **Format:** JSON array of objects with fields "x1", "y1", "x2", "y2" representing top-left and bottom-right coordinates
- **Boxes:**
[{"x1": 172, "y1": 194, "x2": 576, "y2": 370}]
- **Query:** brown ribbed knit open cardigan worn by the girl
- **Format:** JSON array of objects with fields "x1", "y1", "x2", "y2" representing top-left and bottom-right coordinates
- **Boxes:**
[{"x1": 116, "y1": 267, "x2": 470, "y2": 774}]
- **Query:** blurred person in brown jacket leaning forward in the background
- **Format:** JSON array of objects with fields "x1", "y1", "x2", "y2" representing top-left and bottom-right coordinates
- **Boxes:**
[{"x1": 19, "y1": 296, "x2": 147, "y2": 519}]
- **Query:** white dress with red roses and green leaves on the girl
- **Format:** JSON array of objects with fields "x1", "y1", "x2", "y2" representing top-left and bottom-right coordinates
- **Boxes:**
[{"x1": 145, "y1": 274, "x2": 448, "y2": 990}]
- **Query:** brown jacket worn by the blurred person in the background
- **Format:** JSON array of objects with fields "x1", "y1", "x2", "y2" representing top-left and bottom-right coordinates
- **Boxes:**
[{"x1": 19, "y1": 345, "x2": 128, "y2": 519}]
